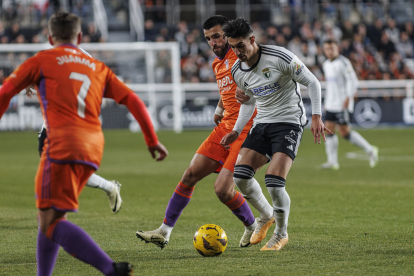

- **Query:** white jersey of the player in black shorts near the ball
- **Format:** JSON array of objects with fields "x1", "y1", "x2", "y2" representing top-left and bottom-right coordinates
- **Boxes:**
[{"x1": 232, "y1": 45, "x2": 322, "y2": 133}]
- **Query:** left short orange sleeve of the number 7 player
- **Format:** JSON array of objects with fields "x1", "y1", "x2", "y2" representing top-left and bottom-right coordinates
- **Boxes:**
[{"x1": 4, "y1": 54, "x2": 42, "y2": 92}]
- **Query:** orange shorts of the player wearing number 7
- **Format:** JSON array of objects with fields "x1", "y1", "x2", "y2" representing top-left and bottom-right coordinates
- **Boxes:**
[{"x1": 35, "y1": 152, "x2": 95, "y2": 212}]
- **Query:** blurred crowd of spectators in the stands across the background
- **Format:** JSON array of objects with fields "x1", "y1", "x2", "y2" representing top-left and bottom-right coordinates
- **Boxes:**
[{"x1": 0, "y1": 0, "x2": 414, "y2": 83}]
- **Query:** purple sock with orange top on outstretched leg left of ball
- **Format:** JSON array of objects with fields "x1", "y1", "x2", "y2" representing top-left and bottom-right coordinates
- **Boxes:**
[{"x1": 164, "y1": 182, "x2": 194, "y2": 227}]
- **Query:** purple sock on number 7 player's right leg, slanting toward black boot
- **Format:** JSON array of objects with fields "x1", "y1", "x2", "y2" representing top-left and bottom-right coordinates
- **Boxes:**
[{"x1": 52, "y1": 220, "x2": 114, "y2": 276}]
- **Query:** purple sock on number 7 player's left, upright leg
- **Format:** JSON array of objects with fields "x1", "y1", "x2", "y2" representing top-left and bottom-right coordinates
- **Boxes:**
[{"x1": 36, "y1": 230, "x2": 59, "y2": 276}]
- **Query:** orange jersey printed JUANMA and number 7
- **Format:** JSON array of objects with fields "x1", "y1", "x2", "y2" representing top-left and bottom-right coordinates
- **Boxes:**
[{"x1": 5, "y1": 44, "x2": 142, "y2": 169}]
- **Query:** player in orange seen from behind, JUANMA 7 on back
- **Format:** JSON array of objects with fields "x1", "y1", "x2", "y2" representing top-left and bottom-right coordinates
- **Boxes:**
[{"x1": 0, "y1": 12, "x2": 167, "y2": 276}]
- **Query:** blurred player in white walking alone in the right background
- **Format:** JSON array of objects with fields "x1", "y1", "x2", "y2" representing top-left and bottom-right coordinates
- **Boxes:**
[{"x1": 321, "y1": 38, "x2": 378, "y2": 170}]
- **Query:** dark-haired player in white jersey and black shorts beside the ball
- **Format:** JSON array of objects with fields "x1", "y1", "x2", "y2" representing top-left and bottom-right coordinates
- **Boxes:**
[{"x1": 222, "y1": 18, "x2": 330, "y2": 251}]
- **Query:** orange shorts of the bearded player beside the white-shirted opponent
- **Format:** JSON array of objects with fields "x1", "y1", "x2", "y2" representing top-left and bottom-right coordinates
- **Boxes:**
[{"x1": 196, "y1": 123, "x2": 249, "y2": 172}]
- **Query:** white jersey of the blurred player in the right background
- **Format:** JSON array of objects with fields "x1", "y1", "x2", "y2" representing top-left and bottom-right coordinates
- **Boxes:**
[{"x1": 323, "y1": 55, "x2": 358, "y2": 113}]
